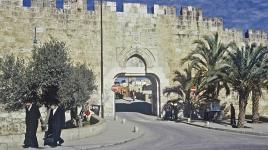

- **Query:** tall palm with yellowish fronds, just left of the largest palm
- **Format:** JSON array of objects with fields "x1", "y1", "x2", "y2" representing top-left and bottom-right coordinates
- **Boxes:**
[{"x1": 182, "y1": 33, "x2": 231, "y2": 100}]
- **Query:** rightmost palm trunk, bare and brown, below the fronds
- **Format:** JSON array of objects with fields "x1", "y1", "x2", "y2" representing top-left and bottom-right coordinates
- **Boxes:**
[{"x1": 252, "y1": 91, "x2": 260, "y2": 123}]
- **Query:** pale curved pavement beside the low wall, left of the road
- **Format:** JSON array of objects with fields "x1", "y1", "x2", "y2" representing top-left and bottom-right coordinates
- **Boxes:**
[{"x1": 11, "y1": 118, "x2": 143, "y2": 150}]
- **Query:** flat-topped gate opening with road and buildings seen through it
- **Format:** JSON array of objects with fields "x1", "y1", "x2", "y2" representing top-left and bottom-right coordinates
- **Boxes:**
[{"x1": 112, "y1": 73, "x2": 160, "y2": 116}]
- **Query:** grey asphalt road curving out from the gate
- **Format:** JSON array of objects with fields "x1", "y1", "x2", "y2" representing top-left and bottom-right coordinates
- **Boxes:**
[{"x1": 99, "y1": 112, "x2": 268, "y2": 150}]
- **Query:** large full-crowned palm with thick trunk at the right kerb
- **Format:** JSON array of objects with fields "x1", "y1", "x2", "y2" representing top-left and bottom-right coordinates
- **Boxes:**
[{"x1": 221, "y1": 44, "x2": 268, "y2": 127}]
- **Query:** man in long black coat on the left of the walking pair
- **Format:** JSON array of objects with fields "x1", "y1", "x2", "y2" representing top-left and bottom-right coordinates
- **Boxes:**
[{"x1": 23, "y1": 100, "x2": 41, "y2": 148}]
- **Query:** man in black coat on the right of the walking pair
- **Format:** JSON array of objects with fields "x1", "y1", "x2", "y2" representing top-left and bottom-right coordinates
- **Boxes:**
[{"x1": 45, "y1": 103, "x2": 65, "y2": 147}]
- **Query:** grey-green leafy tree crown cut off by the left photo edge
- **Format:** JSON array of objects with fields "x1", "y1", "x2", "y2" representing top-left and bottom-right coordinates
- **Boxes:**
[{"x1": 0, "y1": 55, "x2": 27, "y2": 111}]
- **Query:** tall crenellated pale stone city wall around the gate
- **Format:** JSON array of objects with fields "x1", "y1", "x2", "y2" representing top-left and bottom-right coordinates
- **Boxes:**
[{"x1": 0, "y1": 0, "x2": 268, "y2": 118}]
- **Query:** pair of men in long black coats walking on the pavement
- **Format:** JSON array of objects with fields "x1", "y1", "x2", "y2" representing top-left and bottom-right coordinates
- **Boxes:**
[{"x1": 23, "y1": 98, "x2": 65, "y2": 148}]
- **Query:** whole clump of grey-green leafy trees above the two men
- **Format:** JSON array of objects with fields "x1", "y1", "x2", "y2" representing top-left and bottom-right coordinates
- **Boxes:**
[{"x1": 0, "y1": 39, "x2": 96, "y2": 110}]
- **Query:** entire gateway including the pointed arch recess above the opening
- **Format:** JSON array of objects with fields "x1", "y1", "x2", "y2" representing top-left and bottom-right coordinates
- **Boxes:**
[{"x1": 112, "y1": 53, "x2": 160, "y2": 116}]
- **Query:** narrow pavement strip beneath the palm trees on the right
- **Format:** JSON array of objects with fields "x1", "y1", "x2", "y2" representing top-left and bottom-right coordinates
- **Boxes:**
[{"x1": 182, "y1": 119, "x2": 268, "y2": 136}]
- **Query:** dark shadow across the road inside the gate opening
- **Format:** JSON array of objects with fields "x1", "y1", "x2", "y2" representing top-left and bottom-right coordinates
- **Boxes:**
[{"x1": 115, "y1": 101, "x2": 152, "y2": 115}]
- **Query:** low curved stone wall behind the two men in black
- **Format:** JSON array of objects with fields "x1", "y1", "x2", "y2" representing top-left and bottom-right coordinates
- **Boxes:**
[{"x1": 0, "y1": 116, "x2": 106, "y2": 150}]
